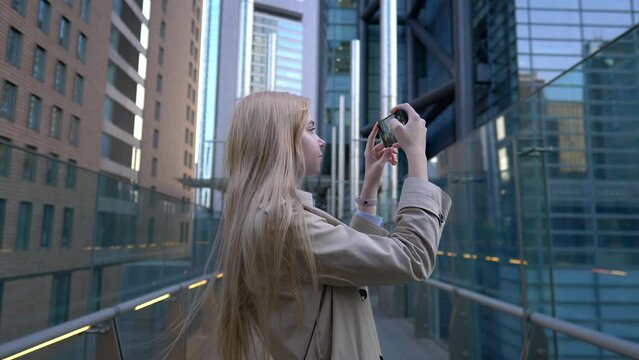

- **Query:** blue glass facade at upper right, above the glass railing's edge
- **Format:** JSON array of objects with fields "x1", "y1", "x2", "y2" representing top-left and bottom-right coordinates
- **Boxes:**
[{"x1": 473, "y1": 0, "x2": 639, "y2": 125}]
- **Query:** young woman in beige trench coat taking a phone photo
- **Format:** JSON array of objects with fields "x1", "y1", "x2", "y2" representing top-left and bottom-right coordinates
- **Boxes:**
[{"x1": 217, "y1": 92, "x2": 450, "y2": 360}]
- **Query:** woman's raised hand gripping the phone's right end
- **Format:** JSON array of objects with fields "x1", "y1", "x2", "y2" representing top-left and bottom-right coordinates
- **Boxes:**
[{"x1": 390, "y1": 103, "x2": 428, "y2": 178}]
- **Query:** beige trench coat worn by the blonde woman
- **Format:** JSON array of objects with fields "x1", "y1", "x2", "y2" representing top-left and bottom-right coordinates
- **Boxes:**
[{"x1": 269, "y1": 178, "x2": 451, "y2": 360}]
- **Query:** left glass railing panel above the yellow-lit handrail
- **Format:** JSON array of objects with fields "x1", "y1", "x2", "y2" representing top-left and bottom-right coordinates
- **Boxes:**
[{"x1": 0, "y1": 143, "x2": 219, "y2": 350}]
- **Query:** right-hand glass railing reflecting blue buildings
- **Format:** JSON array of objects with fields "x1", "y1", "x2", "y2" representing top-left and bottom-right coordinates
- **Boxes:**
[{"x1": 382, "y1": 24, "x2": 639, "y2": 359}]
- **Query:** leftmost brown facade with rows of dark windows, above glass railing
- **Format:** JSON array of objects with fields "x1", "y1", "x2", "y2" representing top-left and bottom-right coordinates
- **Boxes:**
[{"x1": 0, "y1": 0, "x2": 111, "y2": 171}]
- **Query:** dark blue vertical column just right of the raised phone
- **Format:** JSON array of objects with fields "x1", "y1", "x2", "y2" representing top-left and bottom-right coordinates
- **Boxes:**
[{"x1": 453, "y1": 0, "x2": 474, "y2": 140}]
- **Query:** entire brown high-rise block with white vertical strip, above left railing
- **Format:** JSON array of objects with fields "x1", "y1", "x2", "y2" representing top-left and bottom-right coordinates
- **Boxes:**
[{"x1": 0, "y1": 0, "x2": 201, "y2": 199}]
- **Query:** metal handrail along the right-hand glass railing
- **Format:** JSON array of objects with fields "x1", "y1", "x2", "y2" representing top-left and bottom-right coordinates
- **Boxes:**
[{"x1": 423, "y1": 279, "x2": 639, "y2": 359}]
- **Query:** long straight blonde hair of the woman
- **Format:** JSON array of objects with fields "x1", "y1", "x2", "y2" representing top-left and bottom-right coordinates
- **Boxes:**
[{"x1": 217, "y1": 92, "x2": 317, "y2": 360}]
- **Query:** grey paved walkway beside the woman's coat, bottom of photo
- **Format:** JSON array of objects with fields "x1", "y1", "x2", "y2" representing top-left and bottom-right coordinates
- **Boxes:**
[{"x1": 373, "y1": 299, "x2": 448, "y2": 360}]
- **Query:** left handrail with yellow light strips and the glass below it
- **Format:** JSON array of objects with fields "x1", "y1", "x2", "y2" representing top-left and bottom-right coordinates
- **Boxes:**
[{"x1": 0, "y1": 273, "x2": 222, "y2": 360}]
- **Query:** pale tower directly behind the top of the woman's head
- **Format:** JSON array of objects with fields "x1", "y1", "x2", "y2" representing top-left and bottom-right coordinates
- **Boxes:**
[{"x1": 197, "y1": 0, "x2": 320, "y2": 210}]
